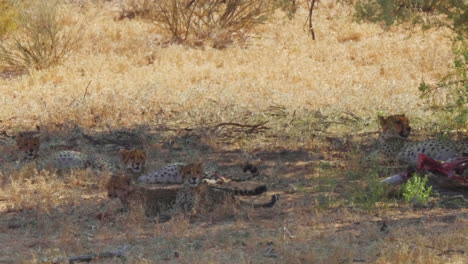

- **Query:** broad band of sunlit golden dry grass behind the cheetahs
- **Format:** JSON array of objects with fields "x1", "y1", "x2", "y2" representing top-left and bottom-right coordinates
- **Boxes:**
[{"x1": 0, "y1": 0, "x2": 451, "y2": 131}]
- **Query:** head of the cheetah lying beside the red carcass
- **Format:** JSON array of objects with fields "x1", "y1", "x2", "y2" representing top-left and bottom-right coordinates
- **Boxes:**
[{"x1": 379, "y1": 115, "x2": 411, "y2": 138}]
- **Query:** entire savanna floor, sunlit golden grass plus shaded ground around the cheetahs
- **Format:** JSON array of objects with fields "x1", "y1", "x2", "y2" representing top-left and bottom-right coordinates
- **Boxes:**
[{"x1": 0, "y1": 1, "x2": 468, "y2": 263}]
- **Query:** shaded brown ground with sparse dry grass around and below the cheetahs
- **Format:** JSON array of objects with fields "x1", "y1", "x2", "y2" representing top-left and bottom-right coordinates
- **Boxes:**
[{"x1": 0, "y1": 126, "x2": 468, "y2": 263}]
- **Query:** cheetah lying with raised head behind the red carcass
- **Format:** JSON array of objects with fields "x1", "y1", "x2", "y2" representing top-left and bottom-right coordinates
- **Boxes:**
[{"x1": 371, "y1": 115, "x2": 468, "y2": 166}]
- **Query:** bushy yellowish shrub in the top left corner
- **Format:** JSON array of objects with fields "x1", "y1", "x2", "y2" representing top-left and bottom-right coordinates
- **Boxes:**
[{"x1": 0, "y1": 0, "x2": 84, "y2": 71}]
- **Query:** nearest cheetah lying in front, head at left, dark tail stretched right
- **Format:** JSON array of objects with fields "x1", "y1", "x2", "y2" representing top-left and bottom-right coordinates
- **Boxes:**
[{"x1": 107, "y1": 175, "x2": 279, "y2": 216}]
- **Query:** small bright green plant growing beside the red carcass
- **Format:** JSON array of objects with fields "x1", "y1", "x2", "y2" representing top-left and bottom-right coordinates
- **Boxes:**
[{"x1": 403, "y1": 174, "x2": 432, "y2": 204}]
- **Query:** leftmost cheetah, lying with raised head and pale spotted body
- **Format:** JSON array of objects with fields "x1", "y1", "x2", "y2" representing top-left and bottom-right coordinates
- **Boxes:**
[{"x1": 16, "y1": 132, "x2": 111, "y2": 171}]
